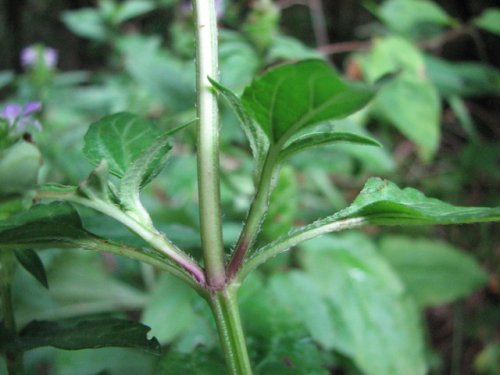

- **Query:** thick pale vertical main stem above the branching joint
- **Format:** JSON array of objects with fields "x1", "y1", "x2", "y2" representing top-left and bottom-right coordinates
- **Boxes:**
[{"x1": 193, "y1": 0, "x2": 226, "y2": 289}]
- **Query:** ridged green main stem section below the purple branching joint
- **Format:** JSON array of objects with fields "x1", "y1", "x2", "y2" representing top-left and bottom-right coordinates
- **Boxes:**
[{"x1": 210, "y1": 284, "x2": 252, "y2": 375}]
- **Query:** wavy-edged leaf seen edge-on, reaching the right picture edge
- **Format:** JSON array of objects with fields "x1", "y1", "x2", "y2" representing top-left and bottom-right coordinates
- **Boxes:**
[{"x1": 331, "y1": 178, "x2": 500, "y2": 225}]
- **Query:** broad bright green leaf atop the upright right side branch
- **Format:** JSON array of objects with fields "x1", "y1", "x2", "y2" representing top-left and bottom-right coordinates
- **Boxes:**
[{"x1": 242, "y1": 60, "x2": 373, "y2": 143}]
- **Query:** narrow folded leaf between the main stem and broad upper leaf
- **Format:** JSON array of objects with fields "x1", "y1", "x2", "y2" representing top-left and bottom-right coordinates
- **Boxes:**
[{"x1": 209, "y1": 78, "x2": 269, "y2": 175}]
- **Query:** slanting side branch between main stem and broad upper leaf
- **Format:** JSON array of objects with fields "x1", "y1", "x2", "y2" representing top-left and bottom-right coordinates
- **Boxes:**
[{"x1": 227, "y1": 145, "x2": 280, "y2": 280}]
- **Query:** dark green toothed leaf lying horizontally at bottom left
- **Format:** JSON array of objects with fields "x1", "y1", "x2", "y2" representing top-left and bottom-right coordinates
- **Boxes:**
[{"x1": 0, "y1": 318, "x2": 161, "y2": 353}]
